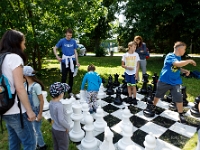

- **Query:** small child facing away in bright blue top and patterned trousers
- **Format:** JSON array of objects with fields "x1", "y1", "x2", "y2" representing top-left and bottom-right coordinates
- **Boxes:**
[{"x1": 81, "y1": 65, "x2": 102, "y2": 113}]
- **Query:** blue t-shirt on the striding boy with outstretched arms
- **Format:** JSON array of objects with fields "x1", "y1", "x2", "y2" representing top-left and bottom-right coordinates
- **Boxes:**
[{"x1": 159, "y1": 53, "x2": 182, "y2": 85}]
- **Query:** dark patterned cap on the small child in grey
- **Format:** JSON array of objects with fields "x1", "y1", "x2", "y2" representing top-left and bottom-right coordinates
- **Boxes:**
[{"x1": 50, "y1": 82, "x2": 70, "y2": 97}]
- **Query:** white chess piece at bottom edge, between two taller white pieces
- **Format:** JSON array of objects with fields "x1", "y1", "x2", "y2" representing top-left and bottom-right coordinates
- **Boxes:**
[{"x1": 99, "y1": 127, "x2": 115, "y2": 150}]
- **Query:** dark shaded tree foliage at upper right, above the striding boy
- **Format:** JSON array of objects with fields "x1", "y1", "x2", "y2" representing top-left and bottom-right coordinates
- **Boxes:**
[{"x1": 119, "y1": 0, "x2": 200, "y2": 52}]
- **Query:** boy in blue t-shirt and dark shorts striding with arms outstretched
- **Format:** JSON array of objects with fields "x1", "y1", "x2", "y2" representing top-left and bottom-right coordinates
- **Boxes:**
[{"x1": 147, "y1": 41, "x2": 196, "y2": 123}]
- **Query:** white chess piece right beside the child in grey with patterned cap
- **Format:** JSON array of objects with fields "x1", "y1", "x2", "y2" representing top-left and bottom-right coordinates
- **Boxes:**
[{"x1": 60, "y1": 99, "x2": 74, "y2": 130}]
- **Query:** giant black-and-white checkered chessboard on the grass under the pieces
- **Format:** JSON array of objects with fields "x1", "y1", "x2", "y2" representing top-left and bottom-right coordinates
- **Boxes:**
[{"x1": 74, "y1": 94, "x2": 200, "y2": 150}]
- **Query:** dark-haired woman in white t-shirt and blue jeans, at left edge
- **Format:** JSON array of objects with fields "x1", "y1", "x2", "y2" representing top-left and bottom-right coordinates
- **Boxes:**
[{"x1": 0, "y1": 30, "x2": 36, "y2": 150}]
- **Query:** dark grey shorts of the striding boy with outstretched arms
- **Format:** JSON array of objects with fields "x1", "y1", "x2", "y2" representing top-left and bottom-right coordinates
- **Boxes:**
[{"x1": 155, "y1": 81, "x2": 183, "y2": 103}]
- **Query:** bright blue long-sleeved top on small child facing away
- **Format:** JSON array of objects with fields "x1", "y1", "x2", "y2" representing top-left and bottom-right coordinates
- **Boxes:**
[{"x1": 81, "y1": 71, "x2": 102, "y2": 91}]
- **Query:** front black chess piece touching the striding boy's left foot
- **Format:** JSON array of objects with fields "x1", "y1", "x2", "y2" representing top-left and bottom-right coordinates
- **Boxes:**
[{"x1": 143, "y1": 91, "x2": 156, "y2": 117}]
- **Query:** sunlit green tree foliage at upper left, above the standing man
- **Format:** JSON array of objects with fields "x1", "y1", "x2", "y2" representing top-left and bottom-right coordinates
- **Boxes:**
[{"x1": 0, "y1": 0, "x2": 108, "y2": 70}]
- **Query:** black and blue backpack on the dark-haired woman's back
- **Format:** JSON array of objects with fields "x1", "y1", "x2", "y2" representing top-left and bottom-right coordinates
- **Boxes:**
[{"x1": 0, "y1": 52, "x2": 23, "y2": 131}]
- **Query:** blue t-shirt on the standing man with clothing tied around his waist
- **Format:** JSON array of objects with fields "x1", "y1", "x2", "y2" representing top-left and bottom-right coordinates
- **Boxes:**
[{"x1": 56, "y1": 38, "x2": 77, "y2": 56}]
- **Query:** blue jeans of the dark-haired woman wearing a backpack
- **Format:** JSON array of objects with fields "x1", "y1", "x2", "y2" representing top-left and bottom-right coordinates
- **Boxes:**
[{"x1": 3, "y1": 113, "x2": 36, "y2": 150}]
